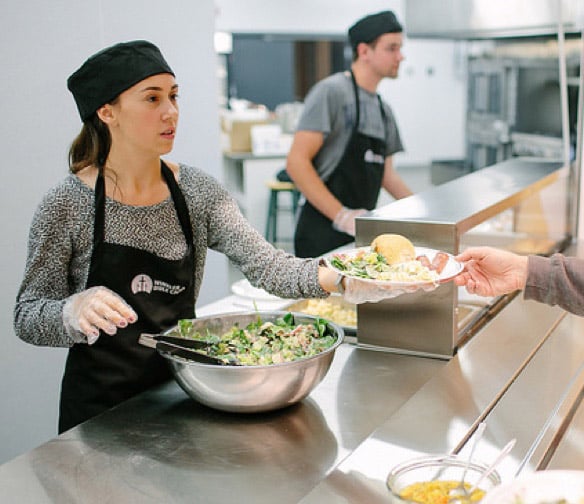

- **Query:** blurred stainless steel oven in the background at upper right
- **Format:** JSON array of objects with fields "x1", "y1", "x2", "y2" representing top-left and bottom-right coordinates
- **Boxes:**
[{"x1": 466, "y1": 54, "x2": 579, "y2": 170}]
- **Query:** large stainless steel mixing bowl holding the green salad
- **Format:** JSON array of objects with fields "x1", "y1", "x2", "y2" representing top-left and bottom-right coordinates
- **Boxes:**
[{"x1": 160, "y1": 311, "x2": 344, "y2": 413}]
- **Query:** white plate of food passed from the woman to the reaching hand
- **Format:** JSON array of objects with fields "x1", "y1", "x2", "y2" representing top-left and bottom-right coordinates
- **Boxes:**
[{"x1": 325, "y1": 243, "x2": 464, "y2": 287}]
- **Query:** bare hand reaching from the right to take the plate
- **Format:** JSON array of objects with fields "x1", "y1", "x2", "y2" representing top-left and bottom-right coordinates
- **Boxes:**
[{"x1": 454, "y1": 247, "x2": 528, "y2": 296}]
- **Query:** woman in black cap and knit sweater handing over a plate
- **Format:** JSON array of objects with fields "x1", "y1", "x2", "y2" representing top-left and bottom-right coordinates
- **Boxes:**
[{"x1": 14, "y1": 41, "x2": 406, "y2": 432}]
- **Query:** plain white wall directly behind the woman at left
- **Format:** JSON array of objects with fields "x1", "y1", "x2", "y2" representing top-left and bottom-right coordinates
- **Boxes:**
[{"x1": 0, "y1": 0, "x2": 222, "y2": 463}]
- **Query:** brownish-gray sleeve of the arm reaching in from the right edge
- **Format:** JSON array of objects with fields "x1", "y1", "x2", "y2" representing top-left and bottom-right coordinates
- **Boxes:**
[{"x1": 524, "y1": 254, "x2": 584, "y2": 315}]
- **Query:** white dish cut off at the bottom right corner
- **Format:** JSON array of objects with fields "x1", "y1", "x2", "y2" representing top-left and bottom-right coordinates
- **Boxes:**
[{"x1": 481, "y1": 470, "x2": 584, "y2": 504}]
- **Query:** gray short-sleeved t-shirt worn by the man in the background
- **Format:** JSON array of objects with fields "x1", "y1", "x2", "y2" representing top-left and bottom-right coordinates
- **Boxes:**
[{"x1": 297, "y1": 72, "x2": 403, "y2": 181}]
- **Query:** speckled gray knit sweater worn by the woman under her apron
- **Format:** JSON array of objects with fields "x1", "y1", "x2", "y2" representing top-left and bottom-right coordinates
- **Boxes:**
[{"x1": 14, "y1": 165, "x2": 328, "y2": 347}]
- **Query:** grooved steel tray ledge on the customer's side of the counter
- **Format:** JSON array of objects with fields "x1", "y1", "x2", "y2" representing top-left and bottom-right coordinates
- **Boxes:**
[{"x1": 301, "y1": 297, "x2": 584, "y2": 504}]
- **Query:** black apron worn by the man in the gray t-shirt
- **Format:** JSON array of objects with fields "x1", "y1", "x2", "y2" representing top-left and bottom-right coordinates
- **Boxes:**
[{"x1": 294, "y1": 72, "x2": 387, "y2": 257}]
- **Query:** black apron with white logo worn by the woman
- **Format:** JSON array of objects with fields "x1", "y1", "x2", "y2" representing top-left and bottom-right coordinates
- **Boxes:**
[{"x1": 59, "y1": 162, "x2": 195, "y2": 433}]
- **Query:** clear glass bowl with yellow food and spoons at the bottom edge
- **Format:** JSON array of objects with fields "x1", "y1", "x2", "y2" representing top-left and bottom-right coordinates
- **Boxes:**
[{"x1": 387, "y1": 455, "x2": 501, "y2": 504}]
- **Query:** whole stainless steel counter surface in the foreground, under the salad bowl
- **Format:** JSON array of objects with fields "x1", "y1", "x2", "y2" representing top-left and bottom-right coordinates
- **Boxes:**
[{"x1": 0, "y1": 290, "x2": 584, "y2": 504}]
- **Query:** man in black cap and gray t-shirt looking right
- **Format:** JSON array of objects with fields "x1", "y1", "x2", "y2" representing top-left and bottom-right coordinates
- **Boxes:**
[{"x1": 286, "y1": 11, "x2": 412, "y2": 257}]
